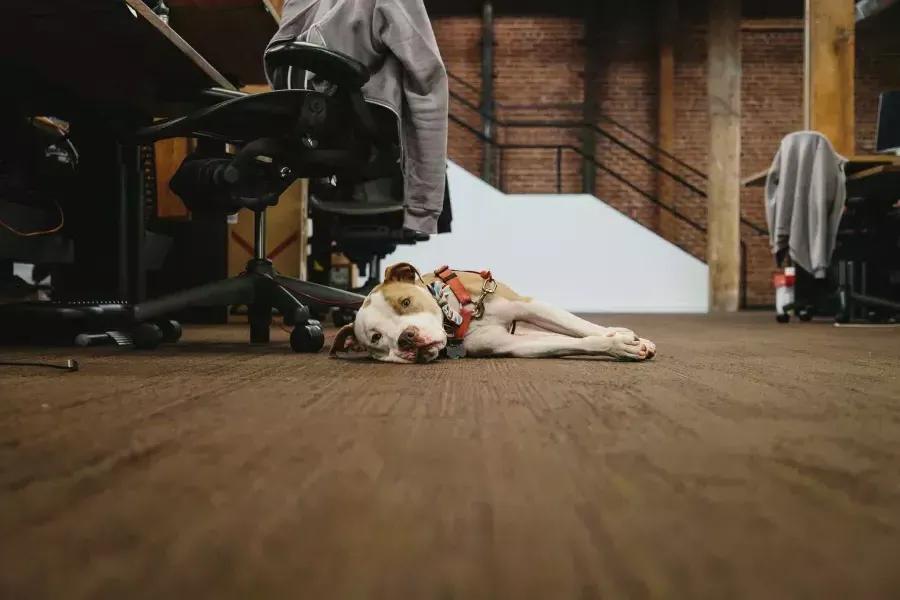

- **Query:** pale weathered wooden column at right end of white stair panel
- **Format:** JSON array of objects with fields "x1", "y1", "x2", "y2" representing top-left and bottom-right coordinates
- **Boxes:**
[{"x1": 706, "y1": 0, "x2": 741, "y2": 312}]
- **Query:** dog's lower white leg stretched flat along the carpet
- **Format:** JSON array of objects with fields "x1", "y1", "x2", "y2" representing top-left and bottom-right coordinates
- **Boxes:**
[{"x1": 465, "y1": 326, "x2": 651, "y2": 360}]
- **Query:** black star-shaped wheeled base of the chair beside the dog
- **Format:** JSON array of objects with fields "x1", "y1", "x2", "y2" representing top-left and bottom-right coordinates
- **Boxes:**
[{"x1": 134, "y1": 259, "x2": 365, "y2": 352}]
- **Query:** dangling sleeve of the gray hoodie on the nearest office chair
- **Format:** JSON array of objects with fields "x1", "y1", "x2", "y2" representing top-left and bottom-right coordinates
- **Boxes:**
[{"x1": 372, "y1": 0, "x2": 449, "y2": 234}]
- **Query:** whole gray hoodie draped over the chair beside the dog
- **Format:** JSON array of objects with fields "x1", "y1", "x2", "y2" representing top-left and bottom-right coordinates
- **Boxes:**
[{"x1": 270, "y1": 0, "x2": 449, "y2": 234}]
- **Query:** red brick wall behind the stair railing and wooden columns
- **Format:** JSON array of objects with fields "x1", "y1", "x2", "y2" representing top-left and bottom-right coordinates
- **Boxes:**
[{"x1": 434, "y1": 2, "x2": 900, "y2": 305}]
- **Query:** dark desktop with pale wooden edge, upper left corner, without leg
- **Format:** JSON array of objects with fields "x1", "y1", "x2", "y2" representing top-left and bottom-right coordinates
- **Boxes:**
[{"x1": 0, "y1": 0, "x2": 236, "y2": 116}]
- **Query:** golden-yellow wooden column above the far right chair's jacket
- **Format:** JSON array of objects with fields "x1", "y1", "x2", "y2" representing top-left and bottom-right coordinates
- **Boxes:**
[{"x1": 804, "y1": 0, "x2": 856, "y2": 156}]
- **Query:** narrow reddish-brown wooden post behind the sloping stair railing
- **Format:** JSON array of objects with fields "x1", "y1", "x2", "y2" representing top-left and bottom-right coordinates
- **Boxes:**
[{"x1": 654, "y1": 0, "x2": 678, "y2": 237}]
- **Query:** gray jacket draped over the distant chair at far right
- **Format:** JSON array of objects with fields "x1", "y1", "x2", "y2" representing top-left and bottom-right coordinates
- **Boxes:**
[{"x1": 766, "y1": 131, "x2": 847, "y2": 279}]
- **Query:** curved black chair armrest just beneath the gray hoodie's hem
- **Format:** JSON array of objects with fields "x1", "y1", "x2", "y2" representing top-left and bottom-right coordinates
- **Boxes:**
[{"x1": 265, "y1": 40, "x2": 370, "y2": 91}]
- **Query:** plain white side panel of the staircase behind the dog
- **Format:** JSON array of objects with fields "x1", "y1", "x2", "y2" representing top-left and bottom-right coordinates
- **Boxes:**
[{"x1": 387, "y1": 162, "x2": 709, "y2": 314}]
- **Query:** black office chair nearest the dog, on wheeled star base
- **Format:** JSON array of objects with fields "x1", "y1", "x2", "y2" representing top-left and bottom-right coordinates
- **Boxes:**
[{"x1": 126, "y1": 41, "x2": 380, "y2": 352}]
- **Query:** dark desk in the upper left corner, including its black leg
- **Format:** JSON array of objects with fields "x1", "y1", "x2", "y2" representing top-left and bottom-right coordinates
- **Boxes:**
[{"x1": 0, "y1": 0, "x2": 236, "y2": 301}]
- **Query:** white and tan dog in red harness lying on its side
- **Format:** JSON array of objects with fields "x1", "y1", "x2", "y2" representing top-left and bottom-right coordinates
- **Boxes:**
[{"x1": 331, "y1": 263, "x2": 656, "y2": 363}]
